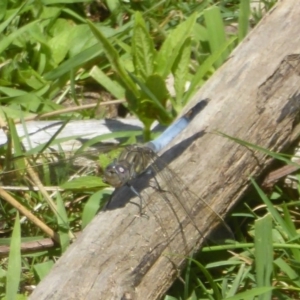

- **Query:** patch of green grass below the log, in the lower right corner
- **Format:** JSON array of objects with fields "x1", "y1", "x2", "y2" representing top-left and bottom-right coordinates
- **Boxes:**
[{"x1": 165, "y1": 176, "x2": 300, "y2": 299}]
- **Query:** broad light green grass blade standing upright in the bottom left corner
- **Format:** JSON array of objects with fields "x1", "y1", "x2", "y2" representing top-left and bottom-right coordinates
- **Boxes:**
[{"x1": 5, "y1": 213, "x2": 21, "y2": 300}]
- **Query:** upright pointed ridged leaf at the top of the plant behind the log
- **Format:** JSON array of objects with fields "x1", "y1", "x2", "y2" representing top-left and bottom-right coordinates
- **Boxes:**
[{"x1": 132, "y1": 12, "x2": 155, "y2": 80}]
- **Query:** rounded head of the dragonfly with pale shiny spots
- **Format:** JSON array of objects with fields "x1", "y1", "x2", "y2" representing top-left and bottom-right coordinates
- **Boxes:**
[{"x1": 102, "y1": 161, "x2": 131, "y2": 188}]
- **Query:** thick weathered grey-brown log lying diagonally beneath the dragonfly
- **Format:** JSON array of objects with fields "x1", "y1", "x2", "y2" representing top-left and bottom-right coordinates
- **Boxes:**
[{"x1": 30, "y1": 0, "x2": 300, "y2": 300}]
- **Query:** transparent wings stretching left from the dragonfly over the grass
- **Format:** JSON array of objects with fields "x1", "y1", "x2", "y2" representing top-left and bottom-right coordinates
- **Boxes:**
[{"x1": 0, "y1": 145, "x2": 122, "y2": 187}]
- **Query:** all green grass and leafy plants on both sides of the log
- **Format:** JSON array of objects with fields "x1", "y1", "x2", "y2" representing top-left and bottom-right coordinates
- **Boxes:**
[{"x1": 0, "y1": 0, "x2": 300, "y2": 299}]
